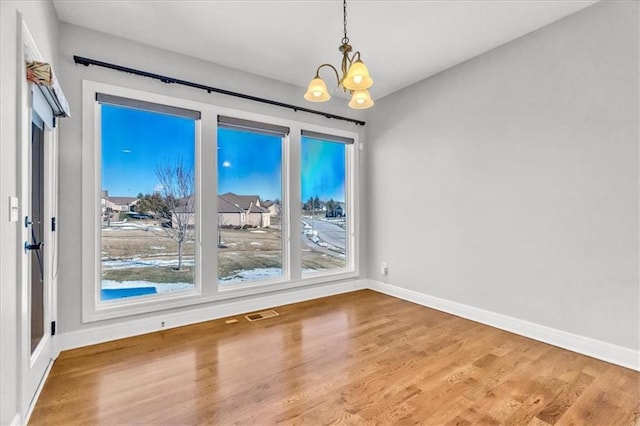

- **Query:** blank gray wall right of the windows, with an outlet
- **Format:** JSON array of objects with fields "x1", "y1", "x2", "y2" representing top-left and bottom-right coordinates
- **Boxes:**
[{"x1": 367, "y1": 1, "x2": 640, "y2": 350}]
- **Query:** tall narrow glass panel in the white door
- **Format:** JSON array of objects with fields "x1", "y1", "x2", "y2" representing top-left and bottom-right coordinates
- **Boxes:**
[{"x1": 28, "y1": 123, "x2": 45, "y2": 353}]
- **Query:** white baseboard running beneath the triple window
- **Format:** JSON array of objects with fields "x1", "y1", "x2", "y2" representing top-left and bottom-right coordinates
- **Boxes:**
[{"x1": 54, "y1": 280, "x2": 363, "y2": 357}]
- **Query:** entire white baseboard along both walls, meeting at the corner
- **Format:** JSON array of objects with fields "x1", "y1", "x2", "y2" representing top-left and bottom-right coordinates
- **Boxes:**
[{"x1": 54, "y1": 279, "x2": 640, "y2": 371}]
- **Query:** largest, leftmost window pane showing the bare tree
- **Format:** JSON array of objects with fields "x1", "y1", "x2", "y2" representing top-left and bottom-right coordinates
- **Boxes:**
[{"x1": 100, "y1": 104, "x2": 196, "y2": 301}]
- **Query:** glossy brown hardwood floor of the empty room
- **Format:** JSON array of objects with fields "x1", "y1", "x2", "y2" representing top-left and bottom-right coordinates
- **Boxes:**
[{"x1": 30, "y1": 290, "x2": 640, "y2": 425}]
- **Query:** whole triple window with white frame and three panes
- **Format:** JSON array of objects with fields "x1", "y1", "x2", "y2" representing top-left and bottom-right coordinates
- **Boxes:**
[{"x1": 82, "y1": 81, "x2": 358, "y2": 322}]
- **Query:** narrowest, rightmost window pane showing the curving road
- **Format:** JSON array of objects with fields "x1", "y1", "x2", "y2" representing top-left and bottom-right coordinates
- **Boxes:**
[{"x1": 301, "y1": 136, "x2": 349, "y2": 274}]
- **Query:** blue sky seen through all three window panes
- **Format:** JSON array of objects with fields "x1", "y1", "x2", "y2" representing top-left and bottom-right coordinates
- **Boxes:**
[{"x1": 102, "y1": 105, "x2": 345, "y2": 202}]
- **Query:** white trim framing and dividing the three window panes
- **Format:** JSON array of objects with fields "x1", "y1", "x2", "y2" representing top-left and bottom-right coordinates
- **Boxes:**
[{"x1": 81, "y1": 80, "x2": 359, "y2": 323}]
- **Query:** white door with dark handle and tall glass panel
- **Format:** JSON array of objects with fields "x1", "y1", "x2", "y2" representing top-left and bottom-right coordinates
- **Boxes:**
[{"x1": 21, "y1": 86, "x2": 57, "y2": 415}]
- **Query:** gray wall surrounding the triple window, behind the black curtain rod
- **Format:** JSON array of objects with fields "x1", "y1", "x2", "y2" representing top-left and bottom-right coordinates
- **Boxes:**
[{"x1": 58, "y1": 23, "x2": 365, "y2": 333}]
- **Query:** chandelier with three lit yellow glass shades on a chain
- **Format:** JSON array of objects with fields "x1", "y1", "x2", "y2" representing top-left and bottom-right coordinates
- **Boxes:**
[{"x1": 304, "y1": 0, "x2": 373, "y2": 109}]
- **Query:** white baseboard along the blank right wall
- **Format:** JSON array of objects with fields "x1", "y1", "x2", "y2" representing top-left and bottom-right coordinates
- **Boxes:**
[{"x1": 361, "y1": 280, "x2": 640, "y2": 371}]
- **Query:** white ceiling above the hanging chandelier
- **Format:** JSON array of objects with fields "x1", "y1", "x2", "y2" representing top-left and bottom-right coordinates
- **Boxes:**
[{"x1": 53, "y1": 0, "x2": 597, "y2": 99}]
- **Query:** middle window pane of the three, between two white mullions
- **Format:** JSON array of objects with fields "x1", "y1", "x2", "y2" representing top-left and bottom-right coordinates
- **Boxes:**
[{"x1": 218, "y1": 127, "x2": 284, "y2": 285}]
